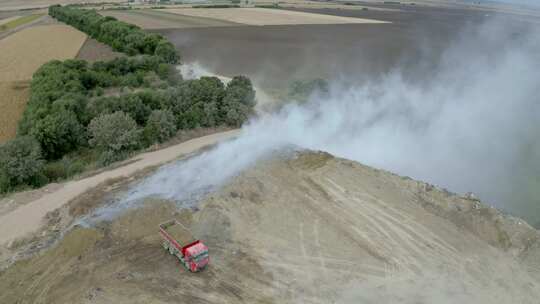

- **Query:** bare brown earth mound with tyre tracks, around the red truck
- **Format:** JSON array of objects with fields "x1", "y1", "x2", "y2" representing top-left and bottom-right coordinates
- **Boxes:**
[{"x1": 0, "y1": 152, "x2": 540, "y2": 304}]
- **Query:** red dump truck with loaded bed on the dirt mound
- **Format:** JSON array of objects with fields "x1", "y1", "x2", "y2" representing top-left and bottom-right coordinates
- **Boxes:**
[{"x1": 159, "y1": 220, "x2": 210, "y2": 272}]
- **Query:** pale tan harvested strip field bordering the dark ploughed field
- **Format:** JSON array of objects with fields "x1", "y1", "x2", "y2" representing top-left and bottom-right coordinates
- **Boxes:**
[{"x1": 167, "y1": 8, "x2": 385, "y2": 25}]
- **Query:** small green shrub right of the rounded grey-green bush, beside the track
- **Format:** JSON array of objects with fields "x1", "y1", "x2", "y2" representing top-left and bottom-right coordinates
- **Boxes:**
[{"x1": 143, "y1": 110, "x2": 176, "y2": 145}]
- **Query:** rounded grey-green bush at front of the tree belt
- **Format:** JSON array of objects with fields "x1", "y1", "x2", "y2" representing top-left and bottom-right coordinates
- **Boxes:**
[{"x1": 88, "y1": 111, "x2": 141, "y2": 155}]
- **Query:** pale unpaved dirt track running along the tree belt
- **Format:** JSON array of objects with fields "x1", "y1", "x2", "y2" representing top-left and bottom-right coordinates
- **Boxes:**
[{"x1": 0, "y1": 130, "x2": 238, "y2": 244}]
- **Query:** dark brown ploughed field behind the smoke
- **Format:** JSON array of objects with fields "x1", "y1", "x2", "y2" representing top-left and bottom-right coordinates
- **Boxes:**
[{"x1": 156, "y1": 5, "x2": 536, "y2": 90}]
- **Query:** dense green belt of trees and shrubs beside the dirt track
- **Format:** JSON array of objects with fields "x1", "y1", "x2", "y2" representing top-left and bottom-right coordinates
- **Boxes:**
[{"x1": 0, "y1": 6, "x2": 255, "y2": 193}]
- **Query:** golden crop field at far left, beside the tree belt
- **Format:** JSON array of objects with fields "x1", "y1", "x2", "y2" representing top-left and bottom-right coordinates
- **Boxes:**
[{"x1": 0, "y1": 24, "x2": 86, "y2": 142}]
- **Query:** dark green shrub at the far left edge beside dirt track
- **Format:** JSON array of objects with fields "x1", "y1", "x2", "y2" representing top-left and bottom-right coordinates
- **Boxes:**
[{"x1": 0, "y1": 136, "x2": 46, "y2": 192}]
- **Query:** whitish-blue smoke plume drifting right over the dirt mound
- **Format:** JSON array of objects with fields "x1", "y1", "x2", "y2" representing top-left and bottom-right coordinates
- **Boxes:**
[{"x1": 86, "y1": 17, "x2": 540, "y2": 221}]
